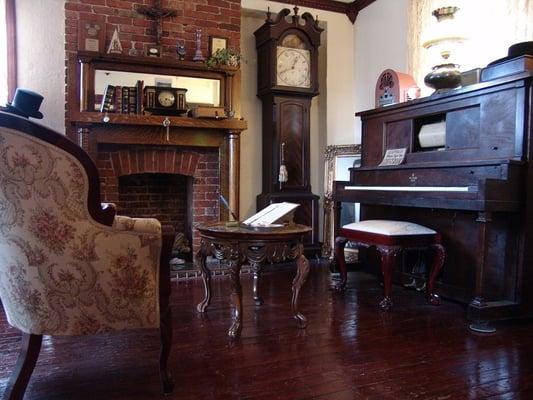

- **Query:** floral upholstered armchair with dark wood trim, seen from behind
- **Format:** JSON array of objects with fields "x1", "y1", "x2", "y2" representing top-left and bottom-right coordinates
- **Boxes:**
[{"x1": 0, "y1": 112, "x2": 173, "y2": 399}]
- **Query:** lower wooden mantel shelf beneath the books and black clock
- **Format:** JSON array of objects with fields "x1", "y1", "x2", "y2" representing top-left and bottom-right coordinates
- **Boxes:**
[{"x1": 69, "y1": 111, "x2": 248, "y2": 131}]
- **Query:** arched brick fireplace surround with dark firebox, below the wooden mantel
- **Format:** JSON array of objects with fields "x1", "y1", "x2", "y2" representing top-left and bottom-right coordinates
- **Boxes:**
[{"x1": 97, "y1": 144, "x2": 220, "y2": 249}]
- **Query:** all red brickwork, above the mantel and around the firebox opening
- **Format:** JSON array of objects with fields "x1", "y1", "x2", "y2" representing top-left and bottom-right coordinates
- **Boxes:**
[{"x1": 65, "y1": 0, "x2": 236, "y2": 250}]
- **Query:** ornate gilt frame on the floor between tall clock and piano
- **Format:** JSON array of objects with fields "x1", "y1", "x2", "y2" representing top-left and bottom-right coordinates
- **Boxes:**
[{"x1": 322, "y1": 144, "x2": 361, "y2": 262}]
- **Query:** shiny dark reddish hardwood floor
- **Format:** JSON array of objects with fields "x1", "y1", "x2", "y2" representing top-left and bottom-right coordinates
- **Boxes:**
[{"x1": 0, "y1": 265, "x2": 533, "y2": 400}]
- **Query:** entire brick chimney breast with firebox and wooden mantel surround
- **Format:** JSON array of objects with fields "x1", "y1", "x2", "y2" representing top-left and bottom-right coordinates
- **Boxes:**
[{"x1": 65, "y1": 0, "x2": 247, "y2": 250}]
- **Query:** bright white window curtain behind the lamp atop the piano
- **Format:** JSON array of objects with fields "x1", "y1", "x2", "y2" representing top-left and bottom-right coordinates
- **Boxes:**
[{"x1": 408, "y1": 0, "x2": 533, "y2": 95}]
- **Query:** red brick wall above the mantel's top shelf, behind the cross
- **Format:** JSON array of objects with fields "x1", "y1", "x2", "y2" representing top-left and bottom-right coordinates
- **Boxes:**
[{"x1": 65, "y1": 0, "x2": 241, "y2": 60}]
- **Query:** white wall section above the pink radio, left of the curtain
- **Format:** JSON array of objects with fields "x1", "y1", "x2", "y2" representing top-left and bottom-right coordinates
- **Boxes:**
[{"x1": 354, "y1": 0, "x2": 409, "y2": 143}]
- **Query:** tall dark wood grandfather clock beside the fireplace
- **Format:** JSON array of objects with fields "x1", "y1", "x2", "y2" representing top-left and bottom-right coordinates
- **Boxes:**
[{"x1": 254, "y1": 7, "x2": 323, "y2": 253}]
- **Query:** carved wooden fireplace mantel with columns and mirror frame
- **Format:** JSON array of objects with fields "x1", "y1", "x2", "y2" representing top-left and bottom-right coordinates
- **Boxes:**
[{"x1": 67, "y1": 52, "x2": 244, "y2": 218}]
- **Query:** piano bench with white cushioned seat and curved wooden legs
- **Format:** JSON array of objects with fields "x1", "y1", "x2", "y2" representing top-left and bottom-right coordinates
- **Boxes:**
[{"x1": 335, "y1": 219, "x2": 445, "y2": 310}]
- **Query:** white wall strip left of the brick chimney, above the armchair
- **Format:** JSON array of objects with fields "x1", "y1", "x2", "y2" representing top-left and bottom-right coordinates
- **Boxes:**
[{"x1": 15, "y1": 0, "x2": 65, "y2": 134}]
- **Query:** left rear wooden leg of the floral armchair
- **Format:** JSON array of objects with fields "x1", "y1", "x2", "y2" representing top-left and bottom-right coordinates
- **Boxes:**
[{"x1": 4, "y1": 333, "x2": 43, "y2": 400}]
